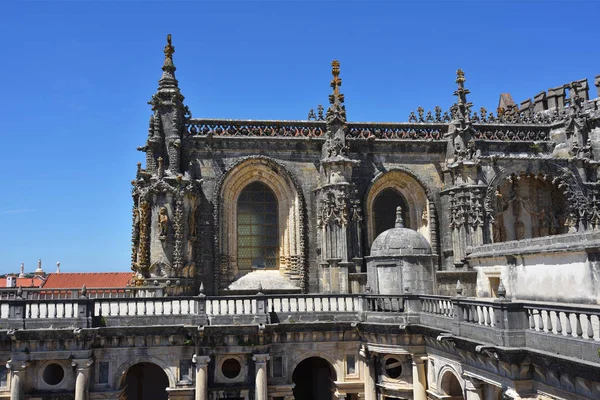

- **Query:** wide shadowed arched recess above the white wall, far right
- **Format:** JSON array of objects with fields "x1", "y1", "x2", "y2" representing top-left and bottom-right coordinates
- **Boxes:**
[{"x1": 492, "y1": 173, "x2": 569, "y2": 243}]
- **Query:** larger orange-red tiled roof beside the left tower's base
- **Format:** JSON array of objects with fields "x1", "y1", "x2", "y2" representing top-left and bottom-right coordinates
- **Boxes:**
[{"x1": 42, "y1": 272, "x2": 133, "y2": 289}]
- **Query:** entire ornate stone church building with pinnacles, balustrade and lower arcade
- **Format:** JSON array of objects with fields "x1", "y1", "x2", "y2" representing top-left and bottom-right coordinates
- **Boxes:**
[{"x1": 0, "y1": 36, "x2": 600, "y2": 400}]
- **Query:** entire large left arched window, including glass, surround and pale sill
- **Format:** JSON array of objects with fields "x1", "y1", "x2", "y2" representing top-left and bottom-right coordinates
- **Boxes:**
[{"x1": 215, "y1": 157, "x2": 307, "y2": 294}]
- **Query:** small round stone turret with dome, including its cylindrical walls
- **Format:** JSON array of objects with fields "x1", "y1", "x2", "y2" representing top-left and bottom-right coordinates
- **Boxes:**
[{"x1": 366, "y1": 207, "x2": 434, "y2": 294}]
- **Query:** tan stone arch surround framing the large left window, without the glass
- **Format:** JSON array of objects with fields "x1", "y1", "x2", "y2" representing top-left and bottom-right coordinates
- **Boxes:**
[{"x1": 215, "y1": 157, "x2": 305, "y2": 290}]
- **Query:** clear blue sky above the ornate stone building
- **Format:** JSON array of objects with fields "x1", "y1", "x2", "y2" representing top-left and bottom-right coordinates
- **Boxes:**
[{"x1": 0, "y1": 1, "x2": 600, "y2": 273}]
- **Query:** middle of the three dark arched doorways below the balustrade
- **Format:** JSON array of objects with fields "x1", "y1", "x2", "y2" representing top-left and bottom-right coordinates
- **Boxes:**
[{"x1": 292, "y1": 357, "x2": 336, "y2": 400}]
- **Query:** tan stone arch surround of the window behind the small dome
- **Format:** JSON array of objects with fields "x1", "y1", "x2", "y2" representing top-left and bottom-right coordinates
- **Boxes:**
[{"x1": 365, "y1": 169, "x2": 432, "y2": 248}]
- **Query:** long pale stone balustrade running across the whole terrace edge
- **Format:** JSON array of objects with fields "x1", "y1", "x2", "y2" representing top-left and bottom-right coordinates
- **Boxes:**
[{"x1": 0, "y1": 294, "x2": 600, "y2": 362}]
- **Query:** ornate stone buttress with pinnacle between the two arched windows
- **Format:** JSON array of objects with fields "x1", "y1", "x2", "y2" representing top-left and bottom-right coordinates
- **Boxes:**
[{"x1": 316, "y1": 60, "x2": 362, "y2": 293}]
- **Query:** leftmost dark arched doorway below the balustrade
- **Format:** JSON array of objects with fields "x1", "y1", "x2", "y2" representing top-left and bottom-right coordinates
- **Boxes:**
[{"x1": 123, "y1": 362, "x2": 169, "y2": 400}]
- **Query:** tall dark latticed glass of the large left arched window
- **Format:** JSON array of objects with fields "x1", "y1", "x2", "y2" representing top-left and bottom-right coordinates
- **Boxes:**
[{"x1": 237, "y1": 181, "x2": 279, "y2": 271}]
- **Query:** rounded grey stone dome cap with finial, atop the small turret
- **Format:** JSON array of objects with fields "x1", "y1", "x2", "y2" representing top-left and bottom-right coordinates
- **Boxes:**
[{"x1": 371, "y1": 207, "x2": 431, "y2": 257}]
